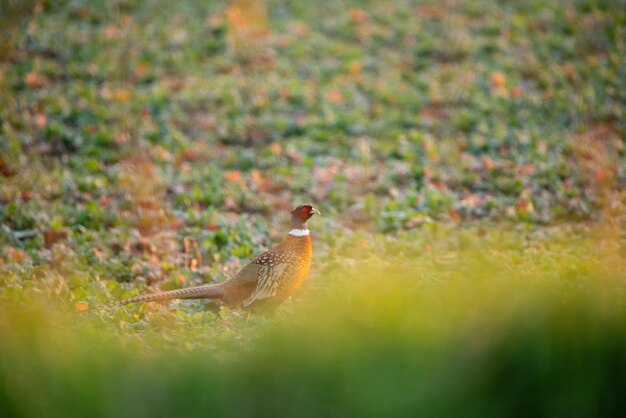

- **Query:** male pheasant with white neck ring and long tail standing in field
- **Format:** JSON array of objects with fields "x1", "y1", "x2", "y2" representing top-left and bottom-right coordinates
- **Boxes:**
[{"x1": 117, "y1": 205, "x2": 320, "y2": 309}]
